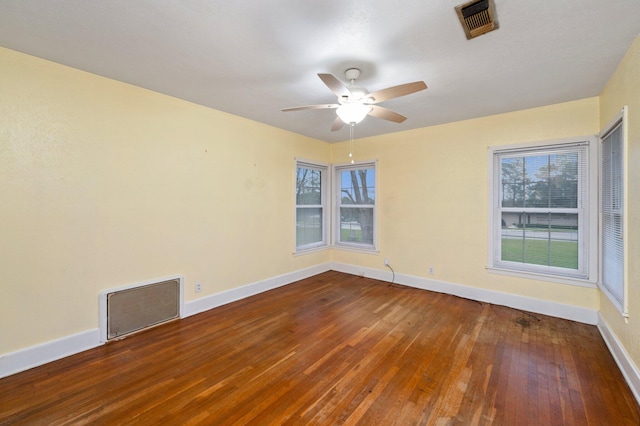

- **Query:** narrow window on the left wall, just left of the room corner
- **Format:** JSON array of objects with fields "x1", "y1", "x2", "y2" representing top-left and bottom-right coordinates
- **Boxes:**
[{"x1": 296, "y1": 161, "x2": 329, "y2": 252}]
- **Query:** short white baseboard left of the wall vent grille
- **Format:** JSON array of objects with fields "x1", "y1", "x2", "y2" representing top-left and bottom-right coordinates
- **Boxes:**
[{"x1": 0, "y1": 328, "x2": 101, "y2": 378}]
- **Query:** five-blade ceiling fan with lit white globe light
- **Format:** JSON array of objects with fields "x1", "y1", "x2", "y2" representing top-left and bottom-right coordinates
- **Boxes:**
[{"x1": 282, "y1": 68, "x2": 427, "y2": 132}]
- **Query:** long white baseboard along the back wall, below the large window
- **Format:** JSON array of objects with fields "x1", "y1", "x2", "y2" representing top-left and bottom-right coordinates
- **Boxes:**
[{"x1": 331, "y1": 262, "x2": 598, "y2": 325}]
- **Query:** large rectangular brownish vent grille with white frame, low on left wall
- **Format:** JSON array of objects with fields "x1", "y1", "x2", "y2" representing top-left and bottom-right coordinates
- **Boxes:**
[{"x1": 101, "y1": 278, "x2": 182, "y2": 341}]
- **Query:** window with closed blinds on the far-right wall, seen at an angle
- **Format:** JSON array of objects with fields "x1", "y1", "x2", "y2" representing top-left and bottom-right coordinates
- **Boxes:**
[{"x1": 600, "y1": 110, "x2": 627, "y2": 315}]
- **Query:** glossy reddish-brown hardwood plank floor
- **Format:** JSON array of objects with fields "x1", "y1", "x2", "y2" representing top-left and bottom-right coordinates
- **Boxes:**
[{"x1": 0, "y1": 272, "x2": 640, "y2": 425}]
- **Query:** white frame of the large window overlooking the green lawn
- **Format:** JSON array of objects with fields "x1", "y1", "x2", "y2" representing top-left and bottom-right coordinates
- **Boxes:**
[{"x1": 487, "y1": 136, "x2": 598, "y2": 288}]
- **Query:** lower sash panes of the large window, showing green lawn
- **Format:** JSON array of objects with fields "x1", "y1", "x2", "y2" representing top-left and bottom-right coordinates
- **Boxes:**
[{"x1": 501, "y1": 212, "x2": 578, "y2": 270}]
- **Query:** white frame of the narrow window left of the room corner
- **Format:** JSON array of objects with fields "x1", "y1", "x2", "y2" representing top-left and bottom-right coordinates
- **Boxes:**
[{"x1": 293, "y1": 158, "x2": 331, "y2": 254}]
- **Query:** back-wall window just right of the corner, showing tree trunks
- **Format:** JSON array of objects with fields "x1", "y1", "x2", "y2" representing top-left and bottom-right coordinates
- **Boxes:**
[{"x1": 334, "y1": 163, "x2": 377, "y2": 250}]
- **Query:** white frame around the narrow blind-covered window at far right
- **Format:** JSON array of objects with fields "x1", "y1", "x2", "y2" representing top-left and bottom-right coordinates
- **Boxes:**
[{"x1": 598, "y1": 106, "x2": 629, "y2": 318}]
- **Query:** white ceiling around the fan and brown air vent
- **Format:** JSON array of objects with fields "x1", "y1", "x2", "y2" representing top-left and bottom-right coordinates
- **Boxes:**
[{"x1": 0, "y1": 0, "x2": 640, "y2": 142}]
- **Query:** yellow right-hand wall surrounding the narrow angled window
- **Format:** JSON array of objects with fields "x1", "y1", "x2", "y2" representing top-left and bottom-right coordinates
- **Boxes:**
[{"x1": 600, "y1": 36, "x2": 640, "y2": 365}]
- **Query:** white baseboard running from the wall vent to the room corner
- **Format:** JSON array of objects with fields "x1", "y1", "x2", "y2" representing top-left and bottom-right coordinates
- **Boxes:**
[{"x1": 183, "y1": 263, "x2": 331, "y2": 317}]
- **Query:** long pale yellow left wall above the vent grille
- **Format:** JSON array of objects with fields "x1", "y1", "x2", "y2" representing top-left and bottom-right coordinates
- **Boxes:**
[{"x1": 0, "y1": 49, "x2": 330, "y2": 354}]
